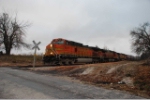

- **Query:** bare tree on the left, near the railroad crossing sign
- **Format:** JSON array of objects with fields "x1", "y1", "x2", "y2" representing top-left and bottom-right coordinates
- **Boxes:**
[{"x1": 0, "y1": 13, "x2": 30, "y2": 55}]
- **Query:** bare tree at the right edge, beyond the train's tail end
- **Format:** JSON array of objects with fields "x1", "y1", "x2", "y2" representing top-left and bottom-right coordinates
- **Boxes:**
[{"x1": 130, "y1": 22, "x2": 150, "y2": 55}]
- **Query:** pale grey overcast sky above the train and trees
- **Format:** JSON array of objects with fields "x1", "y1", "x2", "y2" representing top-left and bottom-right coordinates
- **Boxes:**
[{"x1": 0, "y1": 0, "x2": 150, "y2": 55}]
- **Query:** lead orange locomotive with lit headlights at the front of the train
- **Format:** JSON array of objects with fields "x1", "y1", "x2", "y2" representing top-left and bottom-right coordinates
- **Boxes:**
[{"x1": 43, "y1": 38, "x2": 93, "y2": 65}]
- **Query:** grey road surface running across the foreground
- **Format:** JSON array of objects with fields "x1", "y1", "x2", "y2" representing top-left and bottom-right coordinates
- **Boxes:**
[{"x1": 0, "y1": 67, "x2": 145, "y2": 99}]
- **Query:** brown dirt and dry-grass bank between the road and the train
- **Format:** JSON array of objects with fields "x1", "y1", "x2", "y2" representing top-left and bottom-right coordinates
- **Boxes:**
[{"x1": 0, "y1": 55, "x2": 150, "y2": 98}]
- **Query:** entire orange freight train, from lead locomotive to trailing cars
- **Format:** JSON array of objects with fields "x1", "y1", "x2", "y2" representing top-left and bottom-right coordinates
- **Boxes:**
[{"x1": 43, "y1": 38, "x2": 132, "y2": 65}]
